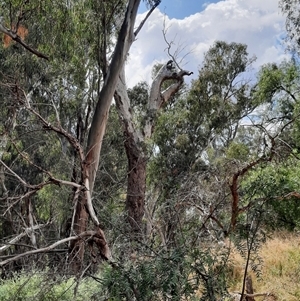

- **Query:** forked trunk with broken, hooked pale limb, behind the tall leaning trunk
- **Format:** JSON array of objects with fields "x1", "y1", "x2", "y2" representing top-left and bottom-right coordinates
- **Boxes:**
[{"x1": 115, "y1": 64, "x2": 191, "y2": 233}]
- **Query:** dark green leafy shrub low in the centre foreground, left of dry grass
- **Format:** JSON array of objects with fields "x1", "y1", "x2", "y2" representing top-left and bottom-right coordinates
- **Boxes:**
[{"x1": 102, "y1": 248, "x2": 220, "y2": 301}]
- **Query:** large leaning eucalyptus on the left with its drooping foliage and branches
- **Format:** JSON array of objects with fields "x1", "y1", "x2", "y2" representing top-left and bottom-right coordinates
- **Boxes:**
[{"x1": 0, "y1": 0, "x2": 160, "y2": 271}]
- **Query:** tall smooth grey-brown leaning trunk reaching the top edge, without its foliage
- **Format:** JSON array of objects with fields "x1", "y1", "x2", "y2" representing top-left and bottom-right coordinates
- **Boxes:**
[{"x1": 69, "y1": 0, "x2": 140, "y2": 273}]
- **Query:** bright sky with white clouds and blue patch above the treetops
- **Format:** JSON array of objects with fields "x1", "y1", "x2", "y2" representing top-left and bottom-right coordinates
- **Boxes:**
[{"x1": 126, "y1": 0, "x2": 289, "y2": 87}]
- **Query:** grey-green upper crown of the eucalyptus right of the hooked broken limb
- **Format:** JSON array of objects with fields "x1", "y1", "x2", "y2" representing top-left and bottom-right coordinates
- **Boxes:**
[{"x1": 149, "y1": 41, "x2": 257, "y2": 195}]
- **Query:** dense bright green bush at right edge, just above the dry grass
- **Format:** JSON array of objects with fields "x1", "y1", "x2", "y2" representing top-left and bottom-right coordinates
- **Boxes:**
[{"x1": 243, "y1": 156, "x2": 300, "y2": 230}]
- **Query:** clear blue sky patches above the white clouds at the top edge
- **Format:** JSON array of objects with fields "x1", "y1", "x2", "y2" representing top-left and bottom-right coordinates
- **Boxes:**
[{"x1": 140, "y1": 0, "x2": 220, "y2": 19}]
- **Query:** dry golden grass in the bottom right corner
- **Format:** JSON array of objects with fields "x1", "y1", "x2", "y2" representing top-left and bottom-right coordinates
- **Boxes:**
[{"x1": 230, "y1": 232, "x2": 300, "y2": 301}]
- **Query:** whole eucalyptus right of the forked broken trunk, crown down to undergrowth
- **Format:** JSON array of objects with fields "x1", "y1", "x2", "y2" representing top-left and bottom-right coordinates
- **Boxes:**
[{"x1": 150, "y1": 41, "x2": 258, "y2": 247}]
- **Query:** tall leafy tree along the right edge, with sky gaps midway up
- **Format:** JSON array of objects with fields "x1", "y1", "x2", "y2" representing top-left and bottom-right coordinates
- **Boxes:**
[{"x1": 245, "y1": 60, "x2": 300, "y2": 229}]
